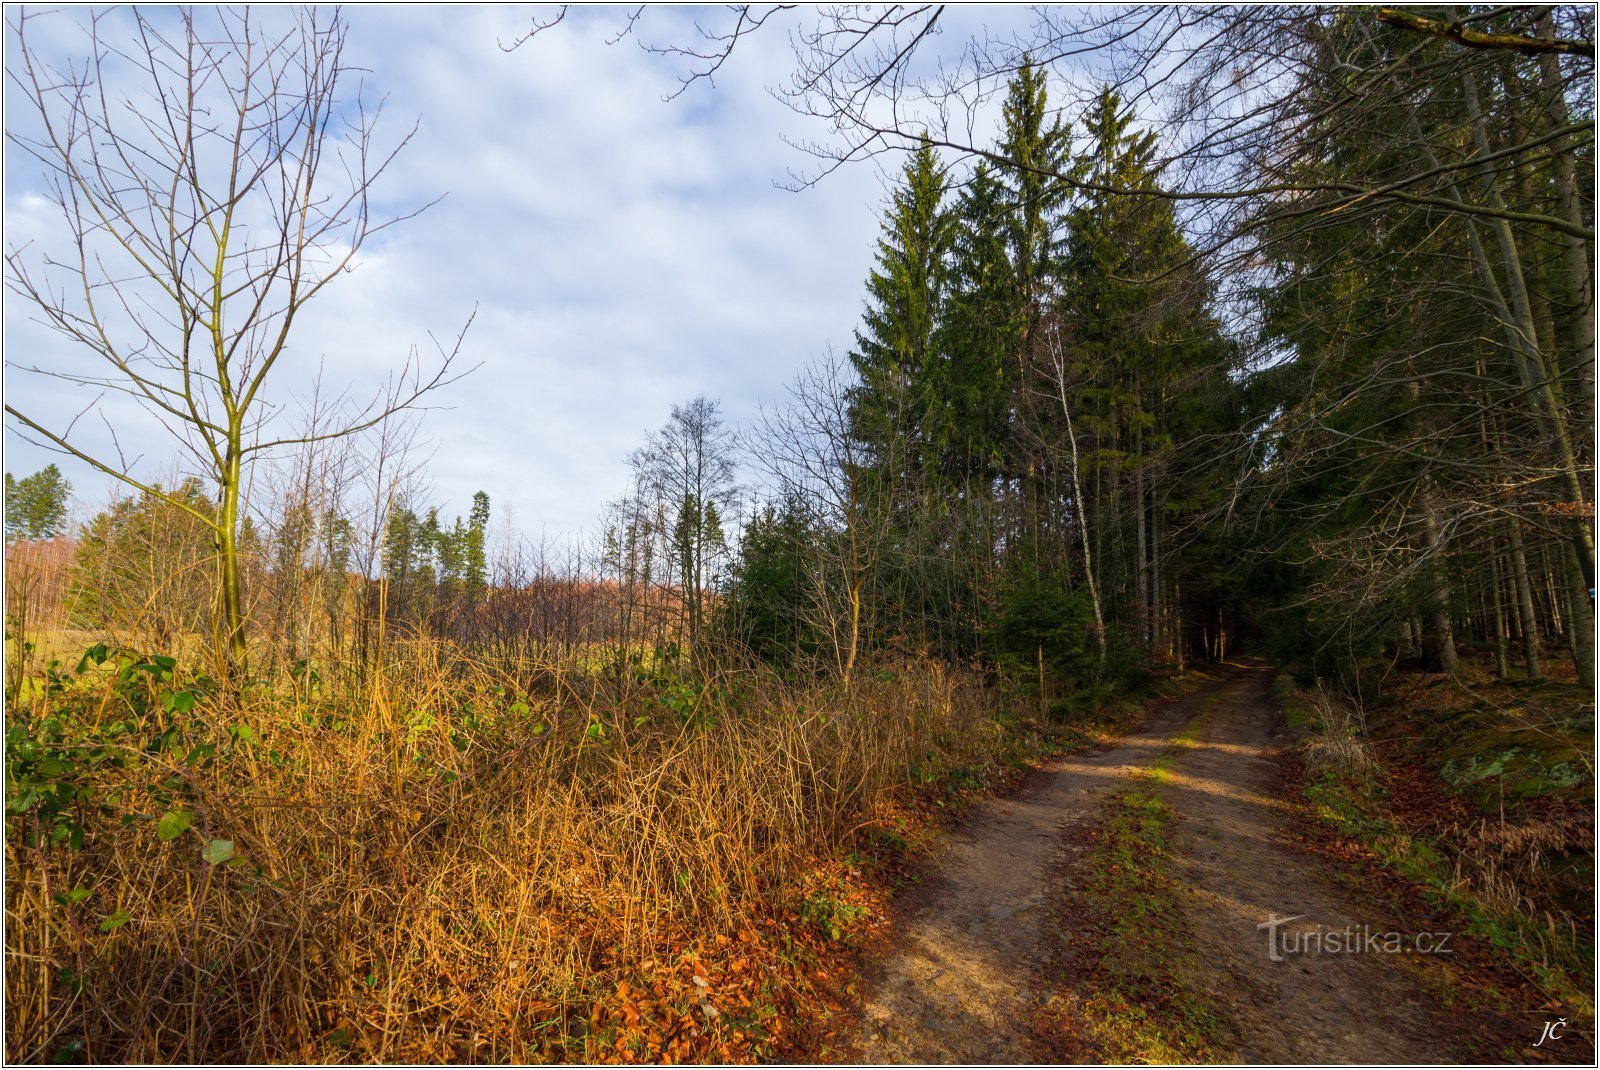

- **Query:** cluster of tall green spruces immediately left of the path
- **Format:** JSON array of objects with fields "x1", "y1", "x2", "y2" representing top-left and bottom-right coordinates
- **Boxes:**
[{"x1": 733, "y1": 75, "x2": 1242, "y2": 693}]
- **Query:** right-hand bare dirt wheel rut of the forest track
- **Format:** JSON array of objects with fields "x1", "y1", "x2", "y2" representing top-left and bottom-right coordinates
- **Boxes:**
[{"x1": 1163, "y1": 672, "x2": 1548, "y2": 1064}]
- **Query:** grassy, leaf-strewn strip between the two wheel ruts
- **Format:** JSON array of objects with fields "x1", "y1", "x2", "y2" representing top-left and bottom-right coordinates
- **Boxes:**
[{"x1": 1035, "y1": 693, "x2": 1226, "y2": 1064}]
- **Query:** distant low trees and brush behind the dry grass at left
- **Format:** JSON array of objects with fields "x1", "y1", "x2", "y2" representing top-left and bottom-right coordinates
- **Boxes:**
[{"x1": 29, "y1": 477, "x2": 618, "y2": 669}]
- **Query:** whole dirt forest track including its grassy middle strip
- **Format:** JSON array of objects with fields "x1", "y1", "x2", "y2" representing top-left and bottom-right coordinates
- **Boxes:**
[{"x1": 821, "y1": 665, "x2": 1594, "y2": 1064}]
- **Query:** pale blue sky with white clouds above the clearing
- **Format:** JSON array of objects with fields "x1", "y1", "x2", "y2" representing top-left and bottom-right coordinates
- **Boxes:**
[{"x1": 3, "y1": 6, "x2": 1030, "y2": 537}]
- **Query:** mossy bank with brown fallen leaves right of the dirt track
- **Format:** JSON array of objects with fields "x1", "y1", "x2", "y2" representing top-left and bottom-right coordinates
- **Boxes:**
[{"x1": 1275, "y1": 675, "x2": 1594, "y2": 1022}]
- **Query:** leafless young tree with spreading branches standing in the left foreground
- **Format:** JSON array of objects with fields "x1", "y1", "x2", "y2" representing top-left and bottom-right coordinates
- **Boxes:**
[{"x1": 5, "y1": 8, "x2": 470, "y2": 672}]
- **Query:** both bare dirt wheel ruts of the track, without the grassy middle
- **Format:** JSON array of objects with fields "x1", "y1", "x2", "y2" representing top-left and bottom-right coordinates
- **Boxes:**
[{"x1": 850, "y1": 669, "x2": 1541, "y2": 1064}]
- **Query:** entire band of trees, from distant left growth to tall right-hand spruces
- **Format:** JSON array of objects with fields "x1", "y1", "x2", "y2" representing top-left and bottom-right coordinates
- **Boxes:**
[{"x1": 8, "y1": 10, "x2": 1594, "y2": 702}]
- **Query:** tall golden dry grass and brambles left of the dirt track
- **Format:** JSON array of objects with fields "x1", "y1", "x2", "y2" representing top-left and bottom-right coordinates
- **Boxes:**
[{"x1": 5, "y1": 643, "x2": 1049, "y2": 1062}]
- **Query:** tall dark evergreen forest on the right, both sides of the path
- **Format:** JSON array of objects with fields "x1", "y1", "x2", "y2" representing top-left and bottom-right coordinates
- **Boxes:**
[{"x1": 716, "y1": 10, "x2": 1595, "y2": 694}]
